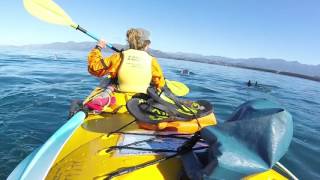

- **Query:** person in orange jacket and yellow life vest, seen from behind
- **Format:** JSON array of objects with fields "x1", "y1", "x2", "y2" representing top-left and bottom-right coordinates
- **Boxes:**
[{"x1": 88, "y1": 28, "x2": 165, "y2": 93}]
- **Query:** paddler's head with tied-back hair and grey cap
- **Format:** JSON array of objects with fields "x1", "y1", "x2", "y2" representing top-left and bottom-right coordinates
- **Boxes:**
[{"x1": 127, "y1": 28, "x2": 151, "y2": 51}]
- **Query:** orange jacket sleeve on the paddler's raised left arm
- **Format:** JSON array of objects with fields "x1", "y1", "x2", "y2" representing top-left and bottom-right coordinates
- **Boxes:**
[{"x1": 88, "y1": 48, "x2": 121, "y2": 77}]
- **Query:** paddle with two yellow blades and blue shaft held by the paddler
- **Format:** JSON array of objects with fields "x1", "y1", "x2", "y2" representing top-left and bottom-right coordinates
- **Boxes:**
[{"x1": 23, "y1": 0, "x2": 189, "y2": 96}]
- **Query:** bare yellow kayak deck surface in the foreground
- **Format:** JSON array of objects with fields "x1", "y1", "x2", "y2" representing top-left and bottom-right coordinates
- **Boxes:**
[{"x1": 46, "y1": 114, "x2": 182, "y2": 179}]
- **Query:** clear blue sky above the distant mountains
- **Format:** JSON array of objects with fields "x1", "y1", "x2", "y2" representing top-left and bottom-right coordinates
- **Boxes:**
[{"x1": 0, "y1": 0, "x2": 320, "y2": 64}]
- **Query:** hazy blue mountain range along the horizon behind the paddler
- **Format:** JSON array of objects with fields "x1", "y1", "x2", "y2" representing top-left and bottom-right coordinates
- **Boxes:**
[{"x1": 1, "y1": 42, "x2": 320, "y2": 81}]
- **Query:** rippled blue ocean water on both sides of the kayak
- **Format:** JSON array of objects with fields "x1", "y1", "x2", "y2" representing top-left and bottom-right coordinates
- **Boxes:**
[{"x1": 0, "y1": 49, "x2": 320, "y2": 179}]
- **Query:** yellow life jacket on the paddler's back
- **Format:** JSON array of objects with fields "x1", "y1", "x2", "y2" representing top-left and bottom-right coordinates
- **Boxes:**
[{"x1": 118, "y1": 49, "x2": 152, "y2": 93}]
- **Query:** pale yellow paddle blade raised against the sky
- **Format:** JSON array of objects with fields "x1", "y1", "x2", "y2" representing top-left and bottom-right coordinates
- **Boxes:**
[{"x1": 23, "y1": 0, "x2": 76, "y2": 27}]
